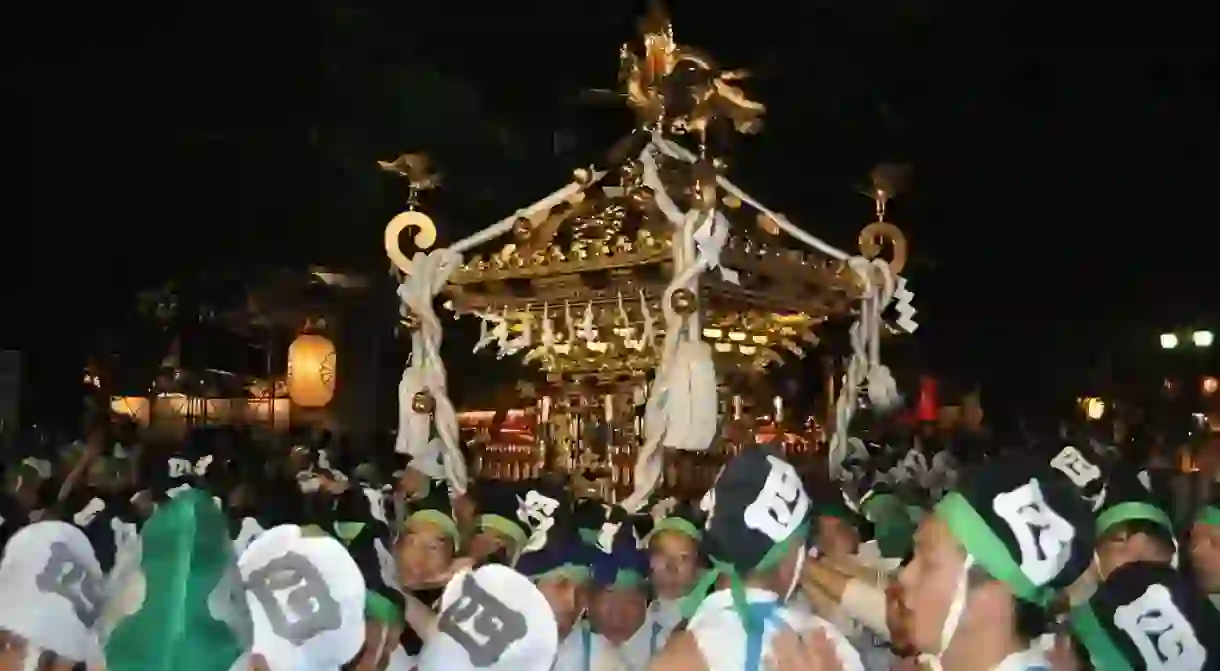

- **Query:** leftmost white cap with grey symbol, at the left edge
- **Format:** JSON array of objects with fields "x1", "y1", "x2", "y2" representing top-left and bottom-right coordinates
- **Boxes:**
[{"x1": 0, "y1": 522, "x2": 102, "y2": 662}]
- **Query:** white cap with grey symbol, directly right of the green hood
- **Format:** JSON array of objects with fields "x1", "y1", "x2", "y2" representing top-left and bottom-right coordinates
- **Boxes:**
[{"x1": 238, "y1": 525, "x2": 365, "y2": 671}]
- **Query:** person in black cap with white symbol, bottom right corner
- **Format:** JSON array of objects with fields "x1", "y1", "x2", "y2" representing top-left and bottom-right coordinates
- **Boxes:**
[{"x1": 1071, "y1": 561, "x2": 1220, "y2": 671}]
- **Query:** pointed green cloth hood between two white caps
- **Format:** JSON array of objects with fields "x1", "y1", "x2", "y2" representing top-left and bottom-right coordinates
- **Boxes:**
[{"x1": 102, "y1": 489, "x2": 251, "y2": 671}]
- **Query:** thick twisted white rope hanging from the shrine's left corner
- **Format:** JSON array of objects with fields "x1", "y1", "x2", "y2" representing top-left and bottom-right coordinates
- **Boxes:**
[{"x1": 394, "y1": 249, "x2": 466, "y2": 494}]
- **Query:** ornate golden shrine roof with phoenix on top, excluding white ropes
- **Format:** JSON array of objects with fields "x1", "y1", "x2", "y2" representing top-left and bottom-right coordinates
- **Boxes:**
[{"x1": 448, "y1": 4, "x2": 859, "y2": 379}]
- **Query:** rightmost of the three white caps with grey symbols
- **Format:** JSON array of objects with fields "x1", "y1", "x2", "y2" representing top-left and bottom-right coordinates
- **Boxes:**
[{"x1": 420, "y1": 564, "x2": 559, "y2": 671}]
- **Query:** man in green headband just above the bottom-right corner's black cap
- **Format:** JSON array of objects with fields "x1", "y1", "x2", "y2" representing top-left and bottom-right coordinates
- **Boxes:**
[{"x1": 1097, "y1": 470, "x2": 1177, "y2": 580}]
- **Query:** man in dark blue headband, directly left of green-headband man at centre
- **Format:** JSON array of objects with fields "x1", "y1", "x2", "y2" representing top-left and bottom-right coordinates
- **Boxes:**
[{"x1": 588, "y1": 524, "x2": 659, "y2": 671}]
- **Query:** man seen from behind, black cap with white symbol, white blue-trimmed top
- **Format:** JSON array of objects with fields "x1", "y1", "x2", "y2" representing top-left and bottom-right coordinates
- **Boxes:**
[{"x1": 650, "y1": 447, "x2": 863, "y2": 671}]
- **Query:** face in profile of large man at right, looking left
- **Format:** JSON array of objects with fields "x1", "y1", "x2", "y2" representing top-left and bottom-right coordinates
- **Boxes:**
[{"x1": 898, "y1": 515, "x2": 966, "y2": 654}]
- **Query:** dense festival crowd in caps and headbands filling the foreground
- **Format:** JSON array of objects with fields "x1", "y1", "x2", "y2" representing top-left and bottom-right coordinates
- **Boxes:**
[{"x1": 0, "y1": 417, "x2": 1220, "y2": 671}]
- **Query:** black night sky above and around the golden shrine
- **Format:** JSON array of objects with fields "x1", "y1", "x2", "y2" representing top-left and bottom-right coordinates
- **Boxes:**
[{"x1": 0, "y1": 0, "x2": 1220, "y2": 427}]
